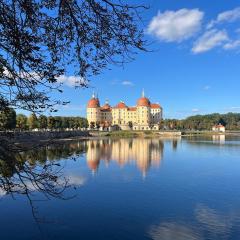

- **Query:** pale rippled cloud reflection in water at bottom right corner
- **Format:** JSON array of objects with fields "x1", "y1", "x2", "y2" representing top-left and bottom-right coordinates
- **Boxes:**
[{"x1": 148, "y1": 204, "x2": 239, "y2": 240}]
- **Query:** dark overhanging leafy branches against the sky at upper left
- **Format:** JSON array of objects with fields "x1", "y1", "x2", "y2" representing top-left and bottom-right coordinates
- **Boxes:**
[{"x1": 0, "y1": 0, "x2": 146, "y2": 112}]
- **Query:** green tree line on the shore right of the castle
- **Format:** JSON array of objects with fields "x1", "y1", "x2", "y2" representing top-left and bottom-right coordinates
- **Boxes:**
[{"x1": 161, "y1": 113, "x2": 240, "y2": 130}]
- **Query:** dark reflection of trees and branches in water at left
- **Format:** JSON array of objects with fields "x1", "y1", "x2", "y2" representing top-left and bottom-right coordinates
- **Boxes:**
[{"x1": 0, "y1": 139, "x2": 86, "y2": 223}]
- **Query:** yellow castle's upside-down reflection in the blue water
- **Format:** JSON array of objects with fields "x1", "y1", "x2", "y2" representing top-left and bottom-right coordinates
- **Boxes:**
[{"x1": 86, "y1": 139, "x2": 164, "y2": 175}]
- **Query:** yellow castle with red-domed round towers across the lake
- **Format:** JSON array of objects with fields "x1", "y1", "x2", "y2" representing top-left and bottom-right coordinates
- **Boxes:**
[{"x1": 87, "y1": 91, "x2": 163, "y2": 130}]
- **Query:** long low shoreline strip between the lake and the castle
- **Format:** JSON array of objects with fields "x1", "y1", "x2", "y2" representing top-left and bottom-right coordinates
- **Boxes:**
[{"x1": 0, "y1": 131, "x2": 240, "y2": 146}]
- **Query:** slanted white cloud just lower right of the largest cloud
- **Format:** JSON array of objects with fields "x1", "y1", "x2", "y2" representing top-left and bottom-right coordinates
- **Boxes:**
[{"x1": 192, "y1": 29, "x2": 229, "y2": 53}]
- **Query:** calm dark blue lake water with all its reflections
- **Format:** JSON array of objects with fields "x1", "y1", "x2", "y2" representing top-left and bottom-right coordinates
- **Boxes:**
[{"x1": 0, "y1": 136, "x2": 240, "y2": 240}]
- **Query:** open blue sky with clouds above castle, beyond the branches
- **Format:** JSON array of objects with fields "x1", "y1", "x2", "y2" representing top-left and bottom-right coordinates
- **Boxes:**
[{"x1": 21, "y1": 0, "x2": 240, "y2": 118}]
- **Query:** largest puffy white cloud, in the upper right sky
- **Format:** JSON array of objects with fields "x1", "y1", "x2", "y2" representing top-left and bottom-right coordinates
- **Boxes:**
[{"x1": 147, "y1": 8, "x2": 204, "y2": 42}]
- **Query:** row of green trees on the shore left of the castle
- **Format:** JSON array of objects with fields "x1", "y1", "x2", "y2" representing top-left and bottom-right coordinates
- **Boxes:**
[{"x1": 0, "y1": 108, "x2": 88, "y2": 131}]
